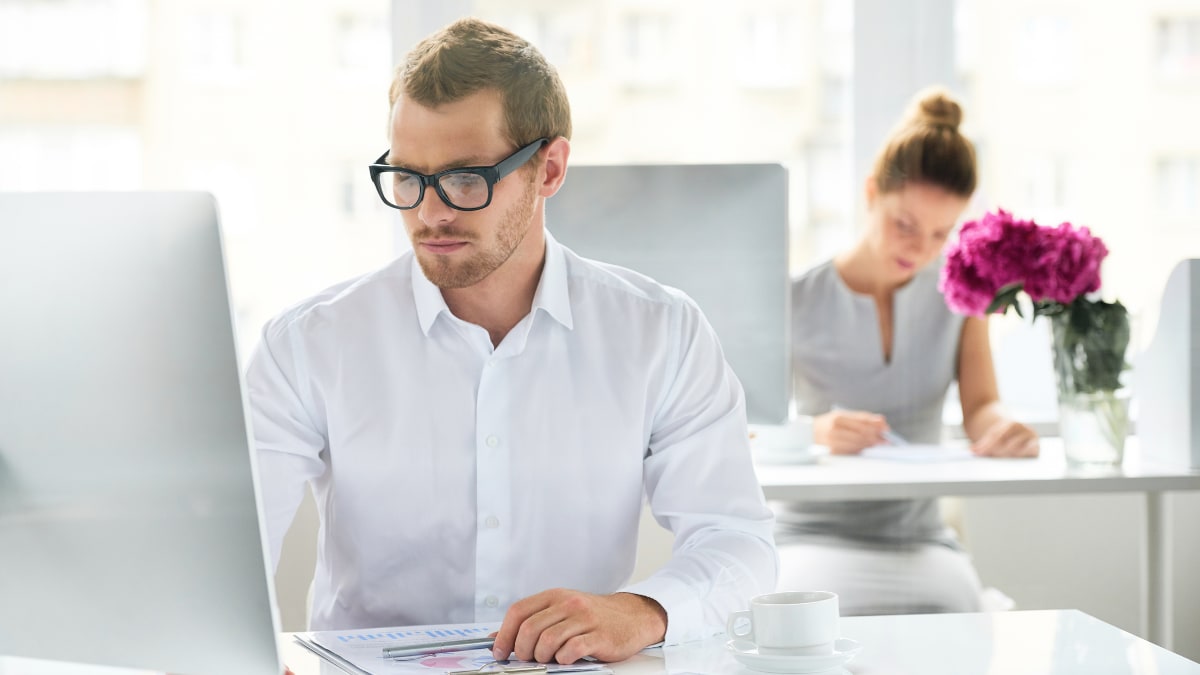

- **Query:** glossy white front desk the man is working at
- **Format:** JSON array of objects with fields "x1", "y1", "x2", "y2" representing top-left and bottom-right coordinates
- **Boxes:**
[{"x1": 0, "y1": 610, "x2": 1200, "y2": 675}]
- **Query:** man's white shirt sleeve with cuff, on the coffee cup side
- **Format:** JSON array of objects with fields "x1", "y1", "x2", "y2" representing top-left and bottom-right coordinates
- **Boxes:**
[{"x1": 622, "y1": 295, "x2": 778, "y2": 644}]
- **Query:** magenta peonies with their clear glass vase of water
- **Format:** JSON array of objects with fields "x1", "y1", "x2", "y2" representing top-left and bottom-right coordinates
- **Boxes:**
[{"x1": 938, "y1": 210, "x2": 1129, "y2": 464}]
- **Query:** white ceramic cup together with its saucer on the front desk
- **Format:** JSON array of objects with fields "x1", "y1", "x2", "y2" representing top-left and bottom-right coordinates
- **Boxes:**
[{"x1": 725, "y1": 591, "x2": 860, "y2": 675}]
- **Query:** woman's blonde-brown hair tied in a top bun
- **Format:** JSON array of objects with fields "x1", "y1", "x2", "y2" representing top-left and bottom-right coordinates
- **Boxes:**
[{"x1": 874, "y1": 88, "x2": 977, "y2": 197}]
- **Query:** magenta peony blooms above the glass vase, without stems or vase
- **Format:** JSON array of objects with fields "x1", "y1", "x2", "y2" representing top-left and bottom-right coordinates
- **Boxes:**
[{"x1": 938, "y1": 209, "x2": 1109, "y2": 316}]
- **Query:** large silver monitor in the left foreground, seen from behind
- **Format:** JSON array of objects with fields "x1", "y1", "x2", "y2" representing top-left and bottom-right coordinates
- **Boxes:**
[{"x1": 0, "y1": 193, "x2": 282, "y2": 675}]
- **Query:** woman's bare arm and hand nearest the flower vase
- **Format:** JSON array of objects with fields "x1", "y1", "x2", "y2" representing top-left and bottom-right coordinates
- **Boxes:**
[{"x1": 959, "y1": 317, "x2": 1038, "y2": 456}]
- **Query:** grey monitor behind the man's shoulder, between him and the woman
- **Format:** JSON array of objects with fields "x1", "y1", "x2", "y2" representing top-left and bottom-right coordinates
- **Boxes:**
[{"x1": 546, "y1": 165, "x2": 791, "y2": 424}]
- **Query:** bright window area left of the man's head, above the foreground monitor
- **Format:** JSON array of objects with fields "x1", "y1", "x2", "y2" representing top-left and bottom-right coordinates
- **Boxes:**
[{"x1": 0, "y1": 0, "x2": 394, "y2": 354}]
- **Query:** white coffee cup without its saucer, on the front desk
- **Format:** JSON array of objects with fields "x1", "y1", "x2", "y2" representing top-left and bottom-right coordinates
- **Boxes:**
[{"x1": 725, "y1": 591, "x2": 838, "y2": 656}]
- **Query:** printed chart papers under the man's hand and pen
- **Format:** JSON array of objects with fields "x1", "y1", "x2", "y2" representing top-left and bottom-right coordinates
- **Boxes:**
[{"x1": 295, "y1": 623, "x2": 612, "y2": 675}]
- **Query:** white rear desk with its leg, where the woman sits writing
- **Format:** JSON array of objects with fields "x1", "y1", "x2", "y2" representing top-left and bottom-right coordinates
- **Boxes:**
[{"x1": 755, "y1": 438, "x2": 1200, "y2": 649}]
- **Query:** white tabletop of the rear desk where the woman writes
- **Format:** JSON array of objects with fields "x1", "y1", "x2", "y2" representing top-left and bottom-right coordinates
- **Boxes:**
[{"x1": 755, "y1": 438, "x2": 1200, "y2": 501}]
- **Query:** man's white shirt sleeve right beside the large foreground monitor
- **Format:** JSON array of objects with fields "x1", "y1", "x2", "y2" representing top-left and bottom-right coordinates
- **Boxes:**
[{"x1": 246, "y1": 319, "x2": 328, "y2": 569}]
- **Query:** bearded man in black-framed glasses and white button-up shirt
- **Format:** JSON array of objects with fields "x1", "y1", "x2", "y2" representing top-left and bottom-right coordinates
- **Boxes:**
[{"x1": 247, "y1": 19, "x2": 775, "y2": 663}]
